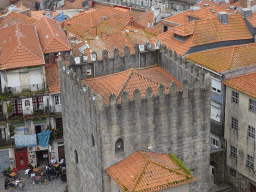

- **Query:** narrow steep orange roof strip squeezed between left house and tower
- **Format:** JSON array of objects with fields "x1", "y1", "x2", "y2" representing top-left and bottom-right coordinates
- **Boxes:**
[{"x1": 45, "y1": 63, "x2": 60, "y2": 94}]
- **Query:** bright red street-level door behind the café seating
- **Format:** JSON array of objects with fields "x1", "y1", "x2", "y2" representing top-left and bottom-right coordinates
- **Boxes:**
[{"x1": 15, "y1": 147, "x2": 28, "y2": 170}]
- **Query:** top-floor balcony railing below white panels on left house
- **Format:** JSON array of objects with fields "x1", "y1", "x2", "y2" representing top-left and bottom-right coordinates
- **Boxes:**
[{"x1": 6, "y1": 83, "x2": 45, "y2": 94}]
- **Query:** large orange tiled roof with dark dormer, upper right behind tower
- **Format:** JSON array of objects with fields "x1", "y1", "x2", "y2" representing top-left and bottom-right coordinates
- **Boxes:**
[{"x1": 152, "y1": 14, "x2": 252, "y2": 55}]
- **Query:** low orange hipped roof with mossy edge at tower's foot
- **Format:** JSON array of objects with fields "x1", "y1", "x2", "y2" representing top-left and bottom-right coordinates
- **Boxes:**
[{"x1": 106, "y1": 150, "x2": 196, "y2": 192}]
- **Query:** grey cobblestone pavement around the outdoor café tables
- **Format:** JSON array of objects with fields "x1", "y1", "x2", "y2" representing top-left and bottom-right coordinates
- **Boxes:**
[{"x1": 0, "y1": 171, "x2": 67, "y2": 192}]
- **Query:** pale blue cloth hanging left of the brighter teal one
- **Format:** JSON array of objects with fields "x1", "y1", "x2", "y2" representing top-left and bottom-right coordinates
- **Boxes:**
[{"x1": 14, "y1": 134, "x2": 37, "y2": 147}]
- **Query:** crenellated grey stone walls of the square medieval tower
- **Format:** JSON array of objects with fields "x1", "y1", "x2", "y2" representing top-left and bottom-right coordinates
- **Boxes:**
[{"x1": 59, "y1": 46, "x2": 211, "y2": 192}]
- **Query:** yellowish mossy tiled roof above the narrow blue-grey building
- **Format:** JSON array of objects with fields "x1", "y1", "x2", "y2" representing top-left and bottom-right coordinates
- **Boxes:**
[{"x1": 186, "y1": 43, "x2": 256, "y2": 73}]
